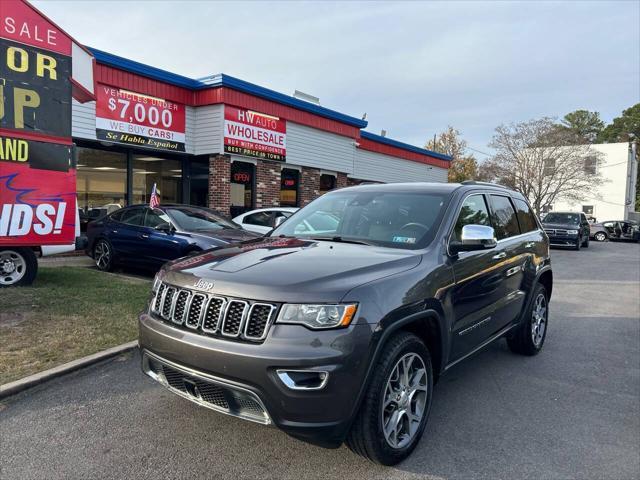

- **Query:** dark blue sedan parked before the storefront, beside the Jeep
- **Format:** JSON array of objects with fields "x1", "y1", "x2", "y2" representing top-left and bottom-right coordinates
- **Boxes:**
[{"x1": 86, "y1": 205, "x2": 259, "y2": 271}]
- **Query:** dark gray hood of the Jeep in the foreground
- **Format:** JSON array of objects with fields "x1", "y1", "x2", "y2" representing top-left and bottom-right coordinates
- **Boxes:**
[{"x1": 164, "y1": 237, "x2": 422, "y2": 302}]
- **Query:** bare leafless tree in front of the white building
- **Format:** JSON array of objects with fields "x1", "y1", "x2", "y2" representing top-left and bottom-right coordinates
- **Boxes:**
[{"x1": 482, "y1": 118, "x2": 603, "y2": 214}]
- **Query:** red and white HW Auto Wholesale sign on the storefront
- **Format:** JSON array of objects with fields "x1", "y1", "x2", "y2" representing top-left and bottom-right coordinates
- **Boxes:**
[{"x1": 224, "y1": 105, "x2": 287, "y2": 161}]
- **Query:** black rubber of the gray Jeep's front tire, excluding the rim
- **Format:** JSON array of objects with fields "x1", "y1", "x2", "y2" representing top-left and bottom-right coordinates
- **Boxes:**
[{"x1": 370, "y1": 335, "x2": 433, "y2": 465}]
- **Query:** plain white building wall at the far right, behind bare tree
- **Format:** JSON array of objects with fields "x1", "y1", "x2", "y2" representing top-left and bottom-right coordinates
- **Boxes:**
[{"x1": 552, "y1": 143, "x2": 637, "y2": 222}]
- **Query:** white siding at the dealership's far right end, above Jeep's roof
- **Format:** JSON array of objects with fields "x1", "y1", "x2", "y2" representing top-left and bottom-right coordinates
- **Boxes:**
[{"x1": 349, "y1": 149, "x2": 447, "y2": 183}]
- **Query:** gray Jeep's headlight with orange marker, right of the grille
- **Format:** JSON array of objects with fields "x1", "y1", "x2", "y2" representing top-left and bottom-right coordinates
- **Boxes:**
[{"x1": 277, "y1": 303, "x2": 358, "y2": 329}]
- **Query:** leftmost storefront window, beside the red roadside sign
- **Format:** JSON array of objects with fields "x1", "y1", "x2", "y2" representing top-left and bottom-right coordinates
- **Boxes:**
[{"x1": 76, "y1": 147, "x2": 127, "y2": 231}]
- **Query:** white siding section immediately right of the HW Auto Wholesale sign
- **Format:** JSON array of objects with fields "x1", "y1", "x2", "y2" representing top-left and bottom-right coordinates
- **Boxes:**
[{"x1": 286, "y1": 122, "x2": 356, "y2": 173}]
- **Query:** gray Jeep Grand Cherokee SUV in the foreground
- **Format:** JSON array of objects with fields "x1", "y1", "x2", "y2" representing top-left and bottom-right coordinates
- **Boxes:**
[{"x1": 140, "y1": 182, "x2": 553, "y2": 465}]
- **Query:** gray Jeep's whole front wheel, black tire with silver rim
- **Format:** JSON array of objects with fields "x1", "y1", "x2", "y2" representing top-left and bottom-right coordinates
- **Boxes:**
[{"x1": 346, "y1": 332, "x2": 433, "y2": 465}]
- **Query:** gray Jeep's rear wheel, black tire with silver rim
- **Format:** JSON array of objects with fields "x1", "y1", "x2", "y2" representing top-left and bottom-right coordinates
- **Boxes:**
[{"x1": 507, "y1": 283, "x2": 549, "y2": 356}]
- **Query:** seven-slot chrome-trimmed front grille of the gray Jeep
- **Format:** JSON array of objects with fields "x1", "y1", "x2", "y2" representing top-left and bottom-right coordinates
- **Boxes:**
[{"x1": 151, "y1": 283, "x2": 277, "y2": 342}]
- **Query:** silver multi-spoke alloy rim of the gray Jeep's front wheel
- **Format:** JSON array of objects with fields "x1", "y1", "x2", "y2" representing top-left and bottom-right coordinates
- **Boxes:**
[{"x1": 382, "y1": 353, "x2": 428, "y2": 448}]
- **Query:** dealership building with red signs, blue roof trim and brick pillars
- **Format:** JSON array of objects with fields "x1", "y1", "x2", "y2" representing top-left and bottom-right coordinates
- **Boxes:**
[{"x1": 67, "y1": 49, "x2": 450, "y2": 216}]
